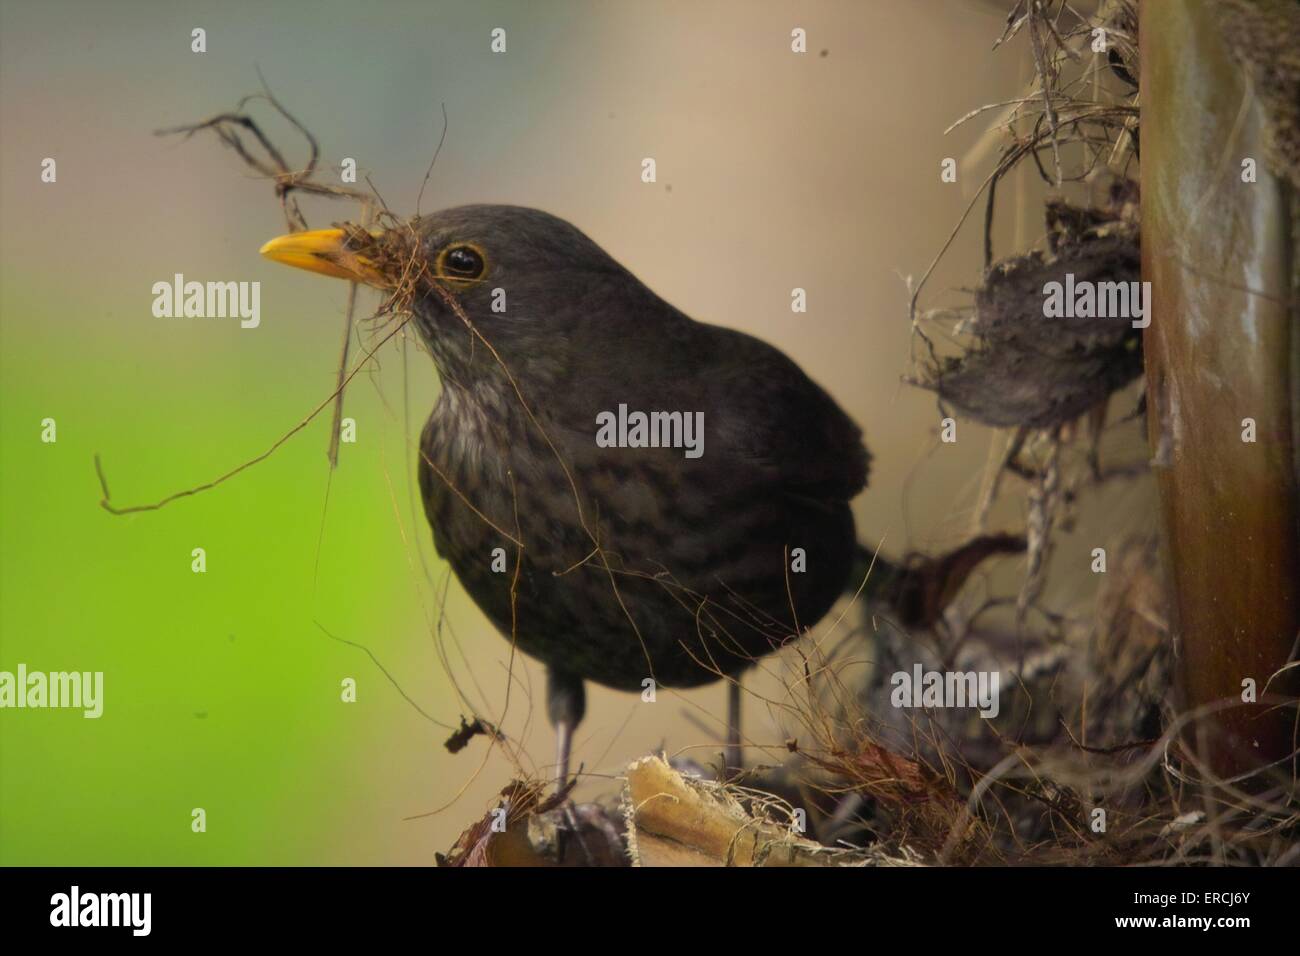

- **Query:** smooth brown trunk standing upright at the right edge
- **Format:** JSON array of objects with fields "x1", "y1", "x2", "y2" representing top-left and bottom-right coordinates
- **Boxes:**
[{"x1": 1140, "y1": 0, "x2": 1300, "y2": 777}]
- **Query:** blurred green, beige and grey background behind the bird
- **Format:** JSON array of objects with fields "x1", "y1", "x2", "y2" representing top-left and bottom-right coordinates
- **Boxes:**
[{"x1": 0, "y1": 0, "x2": 1107, "y2": 864}]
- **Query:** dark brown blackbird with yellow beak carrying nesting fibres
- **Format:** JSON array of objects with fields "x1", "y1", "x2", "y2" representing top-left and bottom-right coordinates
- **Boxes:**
[{"x1": 261, "y1": 206, "x2": 870, "y2": 783}]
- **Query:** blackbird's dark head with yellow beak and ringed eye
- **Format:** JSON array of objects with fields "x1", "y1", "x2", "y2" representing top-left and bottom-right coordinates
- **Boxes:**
[{"x1": 261, "y1": 206, "x2": 660, "y2": 382}]
